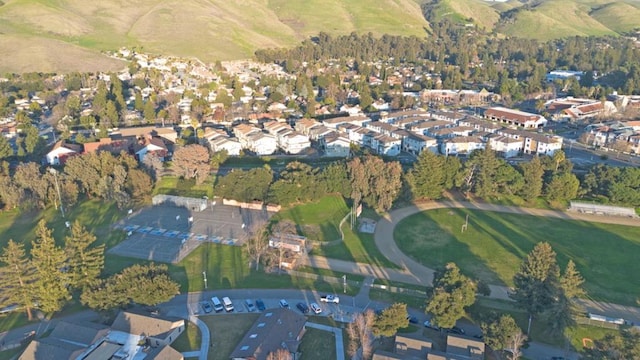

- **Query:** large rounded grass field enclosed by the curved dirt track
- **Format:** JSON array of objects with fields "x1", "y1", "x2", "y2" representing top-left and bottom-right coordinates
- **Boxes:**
[{"x1": 394, "y1": 209, "x2": 640, "y2": 305}]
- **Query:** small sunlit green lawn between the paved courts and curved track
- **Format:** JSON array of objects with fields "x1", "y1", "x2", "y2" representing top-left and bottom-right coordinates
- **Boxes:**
[{"x1": 274, "y1": 196, "x2": 349, "y2": 241}]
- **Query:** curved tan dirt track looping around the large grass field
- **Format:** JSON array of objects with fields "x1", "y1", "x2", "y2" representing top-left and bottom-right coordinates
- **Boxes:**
[{"x1": 308, "y1": 200, "x2": 640, "y2": 324}]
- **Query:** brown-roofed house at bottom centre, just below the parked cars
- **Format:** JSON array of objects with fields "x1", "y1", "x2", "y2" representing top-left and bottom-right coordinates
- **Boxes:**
[{"x1": 230, "y1": 309, "x2": 307, "y2": 360}]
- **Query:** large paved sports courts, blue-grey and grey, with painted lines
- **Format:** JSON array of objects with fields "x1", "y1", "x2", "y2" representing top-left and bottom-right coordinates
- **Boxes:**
[{"x1": 109, "y1": 199, "x2": 273, "y2": 263}]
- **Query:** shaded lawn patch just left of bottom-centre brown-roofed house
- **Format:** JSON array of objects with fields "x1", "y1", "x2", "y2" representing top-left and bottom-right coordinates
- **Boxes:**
[{"x1": 200, "y1": 314, "x2": 260, "y2": 360}]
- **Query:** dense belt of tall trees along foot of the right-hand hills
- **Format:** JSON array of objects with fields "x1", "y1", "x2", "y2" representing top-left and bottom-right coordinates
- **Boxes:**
[{"x1": 255, "y1": 26, "x2": 640, "y2": 100}]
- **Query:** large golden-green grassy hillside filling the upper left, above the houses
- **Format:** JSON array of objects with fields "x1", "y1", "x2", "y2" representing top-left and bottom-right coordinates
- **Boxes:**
[{"x1": 0, "y1": 0, "x2": 428, "y2": 71}]
